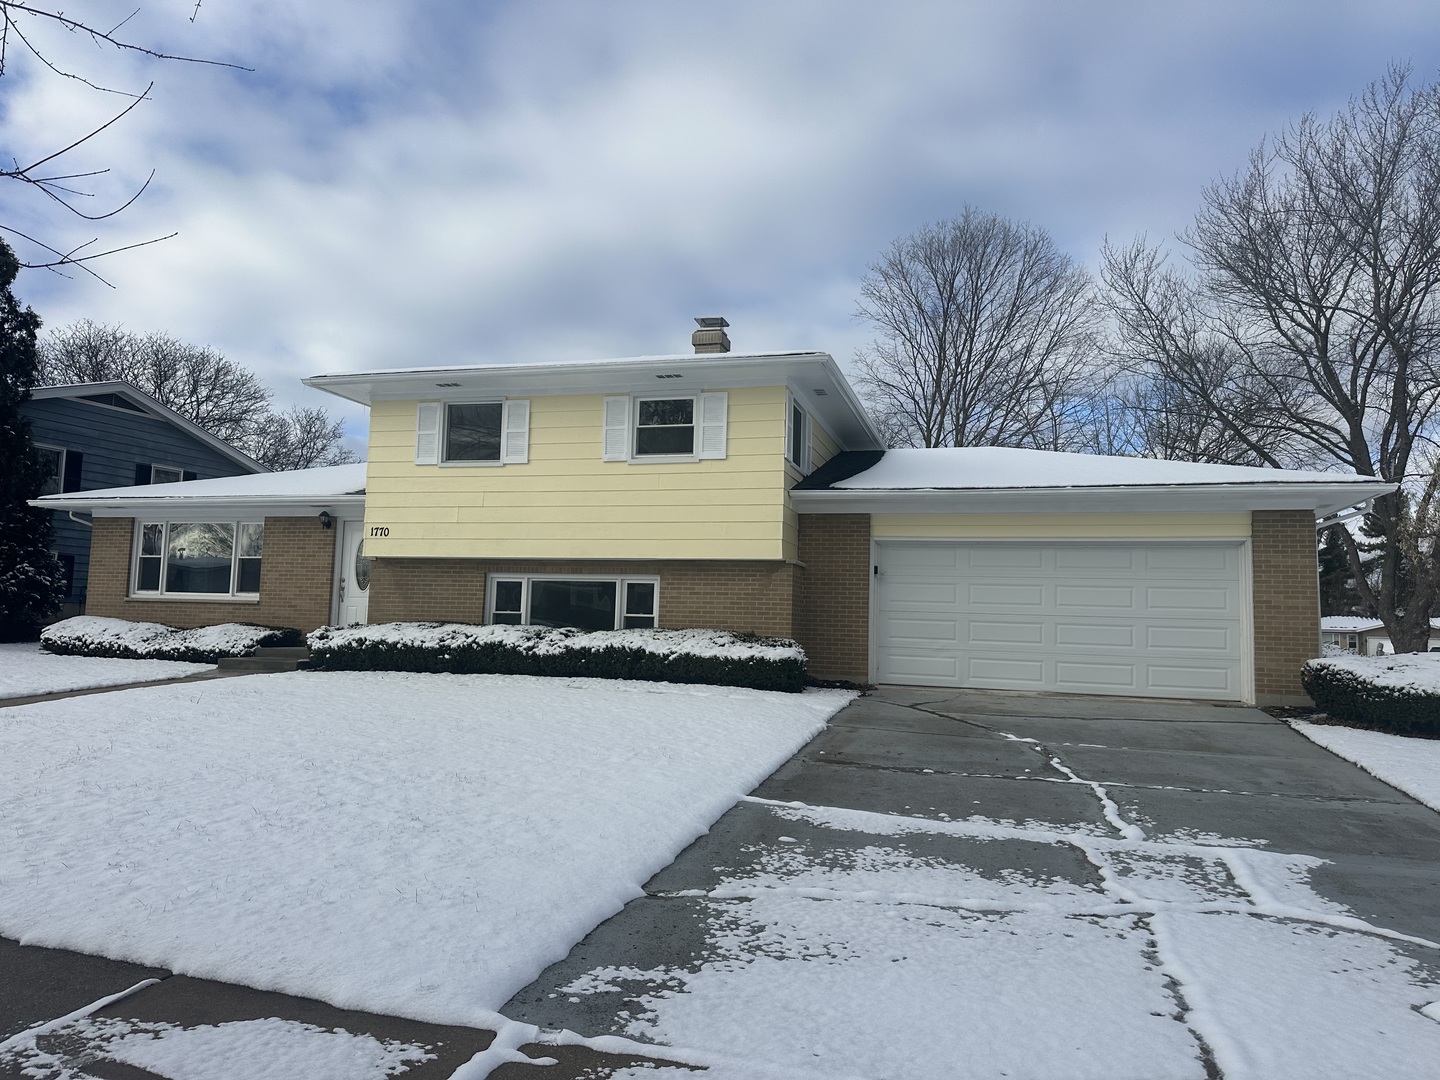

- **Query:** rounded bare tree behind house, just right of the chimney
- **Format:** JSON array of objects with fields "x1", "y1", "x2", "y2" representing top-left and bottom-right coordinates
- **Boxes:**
[{"x1": 857, "y1": 207, "x2": 1094, "y2": 449}]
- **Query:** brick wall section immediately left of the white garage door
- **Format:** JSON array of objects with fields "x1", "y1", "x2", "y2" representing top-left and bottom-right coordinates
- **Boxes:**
[{"x1": 795, "y1": 514, "x2": 870, "y2": 683}]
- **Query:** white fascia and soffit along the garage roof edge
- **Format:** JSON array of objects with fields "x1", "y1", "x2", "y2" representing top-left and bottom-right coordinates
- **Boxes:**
[{"x1": 791, "y1": 482, "x2": 1395, "y2": 517}]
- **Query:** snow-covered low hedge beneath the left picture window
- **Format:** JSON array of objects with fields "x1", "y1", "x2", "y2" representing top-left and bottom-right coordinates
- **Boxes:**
[{"x1": 40, "y1": 615, "x2": 305, "y2": 664}]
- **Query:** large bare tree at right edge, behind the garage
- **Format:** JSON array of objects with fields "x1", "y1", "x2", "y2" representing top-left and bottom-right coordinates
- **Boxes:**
[{"x1": 1104, "y1": 69, "x2": 1440, "y2": 651}]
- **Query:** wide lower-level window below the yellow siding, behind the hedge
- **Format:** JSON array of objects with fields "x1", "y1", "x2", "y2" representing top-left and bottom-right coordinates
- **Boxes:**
[{"x1": 490, "y1": 575, "x2": 660, "y2": 631}]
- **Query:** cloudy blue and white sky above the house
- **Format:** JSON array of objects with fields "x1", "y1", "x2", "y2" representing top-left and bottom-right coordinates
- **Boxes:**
[{"x1": 0, "y1": 0, "x2": 1440, "y2": 443}]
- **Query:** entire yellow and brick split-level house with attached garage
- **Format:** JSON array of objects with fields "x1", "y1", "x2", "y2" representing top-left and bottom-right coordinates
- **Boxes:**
[{"x1": 40, "y1": 321, "x2": 1392, "y2": 703}]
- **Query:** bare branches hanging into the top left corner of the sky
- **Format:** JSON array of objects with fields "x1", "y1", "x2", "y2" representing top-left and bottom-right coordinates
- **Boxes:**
[{"x1": 0, "y1": 0, "x2": 246, "y2": 284}]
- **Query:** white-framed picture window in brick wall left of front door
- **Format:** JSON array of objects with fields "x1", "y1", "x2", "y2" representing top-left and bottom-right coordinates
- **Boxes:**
[{"x1": 135, "y1": 521, "x2": 265, "y2": 596}]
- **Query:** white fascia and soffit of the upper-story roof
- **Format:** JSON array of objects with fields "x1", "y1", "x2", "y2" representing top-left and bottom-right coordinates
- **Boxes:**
[{"x1": 301, "y1": 351, "x2": 884, "y2": 449}]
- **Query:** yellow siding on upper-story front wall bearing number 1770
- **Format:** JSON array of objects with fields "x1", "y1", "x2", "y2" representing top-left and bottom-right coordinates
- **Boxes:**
[{"x1": 366, "y1": 386, "x2": 793, "y2": 559}]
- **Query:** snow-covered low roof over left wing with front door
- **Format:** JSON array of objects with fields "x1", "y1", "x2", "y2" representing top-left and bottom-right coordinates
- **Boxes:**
[{"x1": 30, "y1": 461, "x2": 366, "y2": 514}]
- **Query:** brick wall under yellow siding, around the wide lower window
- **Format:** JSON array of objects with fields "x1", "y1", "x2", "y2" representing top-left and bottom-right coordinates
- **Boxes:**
[{"x1": 370, "y1": 559, "x2": 795, "y2": 638}]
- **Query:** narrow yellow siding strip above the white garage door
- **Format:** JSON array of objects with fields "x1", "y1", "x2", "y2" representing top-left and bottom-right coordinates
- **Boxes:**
[{"x1": 870, "y1": 511, "x2": 1250, "y2": 540}]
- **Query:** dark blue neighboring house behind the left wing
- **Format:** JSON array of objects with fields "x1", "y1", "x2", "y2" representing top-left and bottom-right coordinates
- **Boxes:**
[{"x1": 20, "y1": 382, "x2": 268, "y2": 615}]
